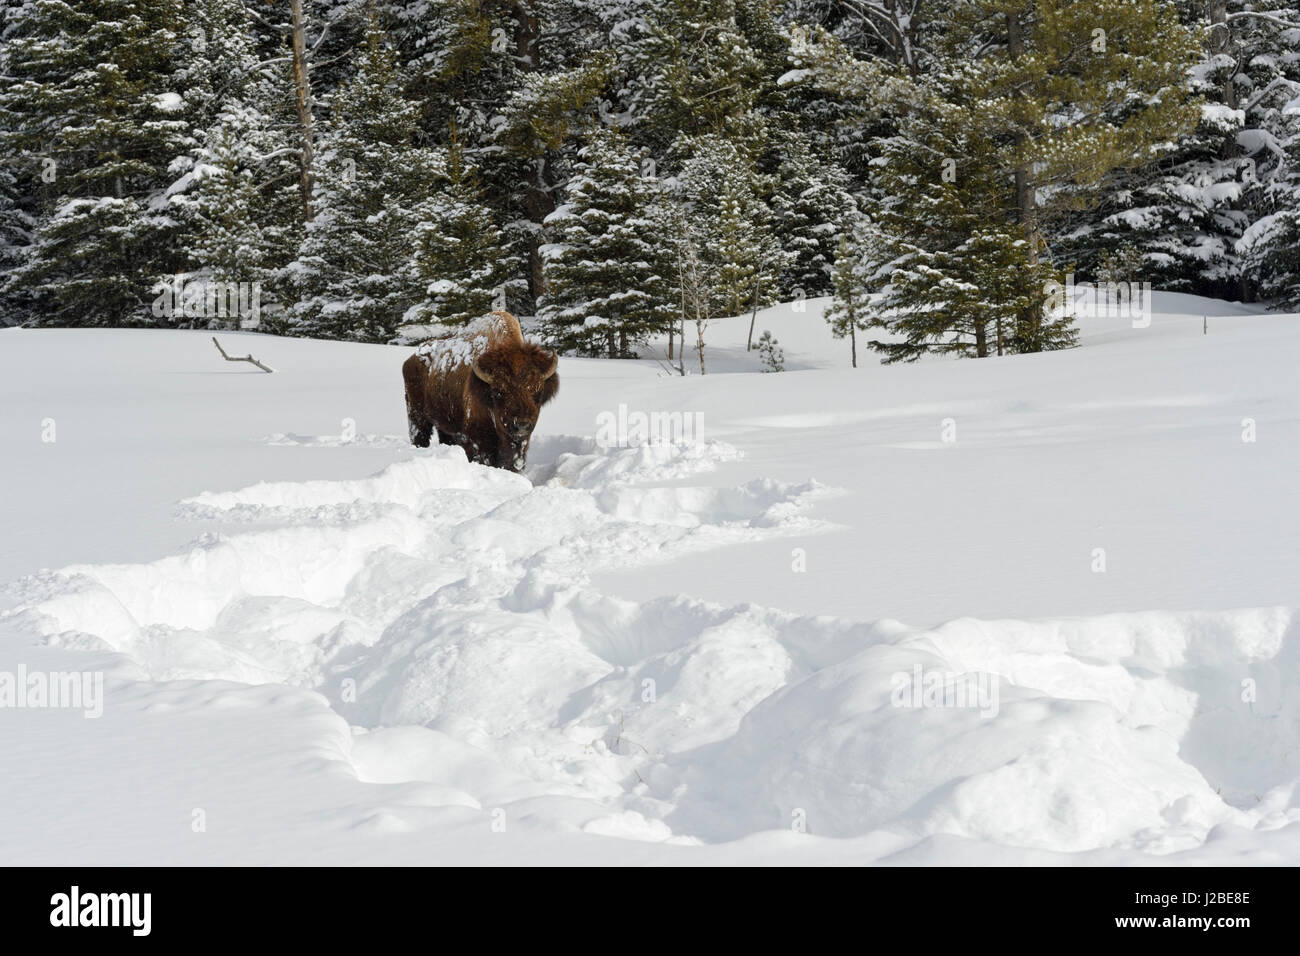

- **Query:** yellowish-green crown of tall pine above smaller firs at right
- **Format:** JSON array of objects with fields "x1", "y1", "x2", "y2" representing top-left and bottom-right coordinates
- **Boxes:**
[{"x1": 931, "y1": 0, "x2": 1199, "y2": 351}]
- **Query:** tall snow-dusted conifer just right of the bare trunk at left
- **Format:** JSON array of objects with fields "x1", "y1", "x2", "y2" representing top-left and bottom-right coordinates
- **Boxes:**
[{"x1": 286, "y1": 21, "x2": 443, "y2": 342}]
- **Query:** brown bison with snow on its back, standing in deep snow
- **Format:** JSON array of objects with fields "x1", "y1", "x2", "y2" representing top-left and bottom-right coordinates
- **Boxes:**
[{"x1": 402, "y1": 312, "x2": 560, "y2": 472}]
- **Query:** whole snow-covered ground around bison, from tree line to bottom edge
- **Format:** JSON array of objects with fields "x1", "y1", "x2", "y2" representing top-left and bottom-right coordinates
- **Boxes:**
[{"x1": 0, "y1": 295, "x2": 1300, "y2": 864}]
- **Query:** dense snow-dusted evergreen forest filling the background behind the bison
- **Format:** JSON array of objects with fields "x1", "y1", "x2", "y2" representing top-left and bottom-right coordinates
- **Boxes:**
[{"x1": 0, "y1": 0, "x2": 1300, "y2": 340}]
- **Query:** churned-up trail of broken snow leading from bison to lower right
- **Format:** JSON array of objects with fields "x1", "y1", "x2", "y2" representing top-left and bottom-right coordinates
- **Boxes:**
[{"x1": 4, "y1": 437, "x2": 1300, "y2": 853}]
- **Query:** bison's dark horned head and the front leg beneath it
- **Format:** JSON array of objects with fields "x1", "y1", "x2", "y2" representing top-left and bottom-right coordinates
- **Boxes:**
[{"x1": 469, "y1": 342, "x2": 560, "y2": 472}]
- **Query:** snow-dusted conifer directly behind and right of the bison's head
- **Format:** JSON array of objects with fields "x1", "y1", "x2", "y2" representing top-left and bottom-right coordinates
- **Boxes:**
[{"x1": 538, "y1": 127, "x2": 677, "y2": 359}]
